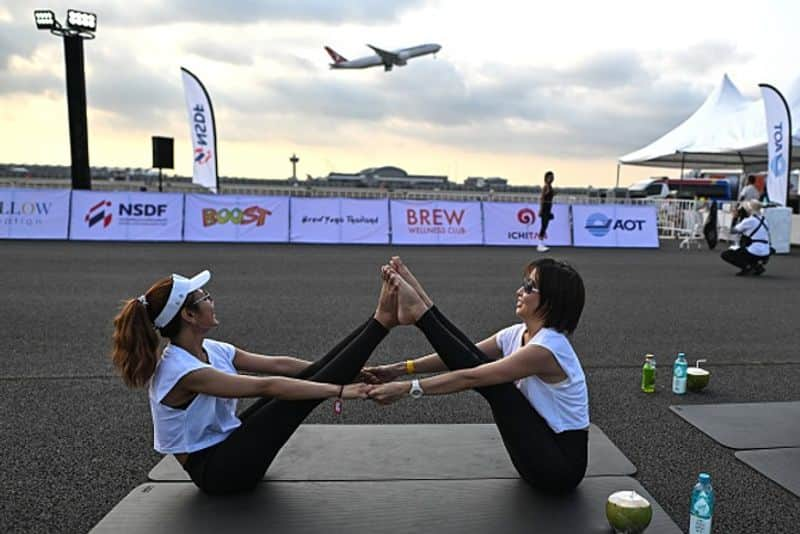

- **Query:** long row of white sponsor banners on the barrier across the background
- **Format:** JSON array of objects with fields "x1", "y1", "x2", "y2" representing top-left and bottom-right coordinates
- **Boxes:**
[{"x1": 0, "y1": 189, "x2": 730, "y2": 247}]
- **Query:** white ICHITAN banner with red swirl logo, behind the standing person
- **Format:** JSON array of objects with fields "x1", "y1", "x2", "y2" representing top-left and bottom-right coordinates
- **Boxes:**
[{"x1": 483, "y1": 202, "x2": 572, "y2": 246}]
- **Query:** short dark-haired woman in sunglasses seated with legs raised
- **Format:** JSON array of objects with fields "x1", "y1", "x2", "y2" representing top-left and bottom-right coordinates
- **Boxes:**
[{"x1": 366, "y1": 257, "x2": 589, "y2": 493}]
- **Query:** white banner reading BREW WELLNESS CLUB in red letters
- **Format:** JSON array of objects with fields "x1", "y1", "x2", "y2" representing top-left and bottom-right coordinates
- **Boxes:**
[{"x1": 390, "y1": 200, "x2": 483, "y2": 245}]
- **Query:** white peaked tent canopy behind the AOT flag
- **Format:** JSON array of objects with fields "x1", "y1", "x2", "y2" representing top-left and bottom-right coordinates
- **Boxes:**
[{"x1": 619, "y1": 74, "x2": 800, "y2": 172}]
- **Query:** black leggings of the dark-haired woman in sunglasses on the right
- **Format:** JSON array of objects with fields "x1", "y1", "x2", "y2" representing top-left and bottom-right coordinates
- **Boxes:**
[{"x1": 417, "y1": 306, "x2": 589, "y2": 493}]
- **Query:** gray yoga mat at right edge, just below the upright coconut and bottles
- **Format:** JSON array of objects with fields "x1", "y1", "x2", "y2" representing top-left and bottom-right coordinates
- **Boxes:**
[{"x1": 670, "y1": 402, "x2": 800, "y2": 449}]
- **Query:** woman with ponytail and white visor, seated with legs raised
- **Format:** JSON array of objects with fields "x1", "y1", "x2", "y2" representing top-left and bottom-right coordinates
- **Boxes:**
[{"x1": 111, "y1": 271, "x2": 397, "y2": 494}]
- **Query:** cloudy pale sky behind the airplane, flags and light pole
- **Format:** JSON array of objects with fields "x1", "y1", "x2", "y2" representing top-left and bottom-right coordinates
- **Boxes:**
[{"x1": 0, "y1": 0, "x2": 800, "y2": 187}]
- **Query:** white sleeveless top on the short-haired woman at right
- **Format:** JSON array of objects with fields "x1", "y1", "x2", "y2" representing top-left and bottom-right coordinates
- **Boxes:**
[{"x1": 495, "y1": 323, "x2": 589, "y2": 433}]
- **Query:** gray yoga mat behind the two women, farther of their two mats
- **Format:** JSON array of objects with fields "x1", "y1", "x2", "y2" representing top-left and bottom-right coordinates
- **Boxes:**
[{"x1": 148, "y1": 424, "x2": 636, "y2": 482}]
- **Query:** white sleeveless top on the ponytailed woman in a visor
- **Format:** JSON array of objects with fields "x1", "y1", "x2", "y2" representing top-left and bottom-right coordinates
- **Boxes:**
[{"x1": 148, "y1": 339, "x2": 242, "y2": 454}]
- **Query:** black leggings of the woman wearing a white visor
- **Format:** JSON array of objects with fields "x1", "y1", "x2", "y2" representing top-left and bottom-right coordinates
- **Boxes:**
[{"x1": 184, "y1": 319, "x2": 388, "y2": 494}]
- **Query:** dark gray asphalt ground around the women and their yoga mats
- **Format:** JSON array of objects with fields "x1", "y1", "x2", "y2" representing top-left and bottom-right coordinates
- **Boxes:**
[{"x1": 0, "y1": 241, "x2": 800, "y2": 533}]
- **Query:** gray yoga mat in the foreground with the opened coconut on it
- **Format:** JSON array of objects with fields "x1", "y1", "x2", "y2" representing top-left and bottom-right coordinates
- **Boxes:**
[{"x1": 91, "y1": 477, "x2": 681, "y2": 534}]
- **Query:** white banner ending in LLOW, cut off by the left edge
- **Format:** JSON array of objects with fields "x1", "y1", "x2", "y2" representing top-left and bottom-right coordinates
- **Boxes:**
[{"x1": 0, "y1": 189, "x2": 70, "y2": 239}]
